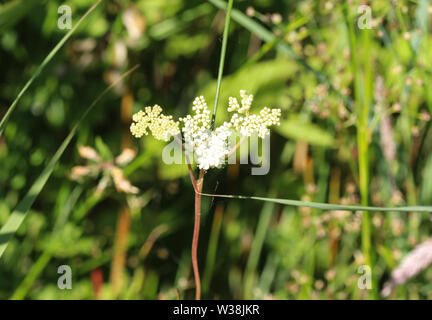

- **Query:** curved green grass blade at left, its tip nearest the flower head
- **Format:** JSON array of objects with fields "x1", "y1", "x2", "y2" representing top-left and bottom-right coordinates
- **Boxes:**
[{"x1": 0, "y1": 65, "x2": 138, "y2": 258}]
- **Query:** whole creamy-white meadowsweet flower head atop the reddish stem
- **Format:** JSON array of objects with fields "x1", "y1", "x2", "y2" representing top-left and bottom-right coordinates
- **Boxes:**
[{"x1": 131, "y1": 90, "x2": 281, "y2": 170}]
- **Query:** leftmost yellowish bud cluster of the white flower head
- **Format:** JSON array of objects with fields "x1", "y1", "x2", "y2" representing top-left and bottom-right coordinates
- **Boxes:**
[{"x1": 130, "y1": 104, "x2": 180, "y2": 141}]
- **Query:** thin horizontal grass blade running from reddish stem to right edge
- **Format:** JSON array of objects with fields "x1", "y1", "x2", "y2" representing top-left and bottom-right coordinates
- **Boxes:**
[{"x1": 201, "y1": 193, "x2": 432, "y2": 212}]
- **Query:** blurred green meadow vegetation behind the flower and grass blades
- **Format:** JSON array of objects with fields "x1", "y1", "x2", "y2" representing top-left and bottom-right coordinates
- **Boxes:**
[{"x1": 0, "y1": 0, "x2": 432, "y2": 299}]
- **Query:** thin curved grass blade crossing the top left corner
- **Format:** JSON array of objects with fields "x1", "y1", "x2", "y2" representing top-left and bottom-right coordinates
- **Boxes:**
[{"x1": 0, "y1": 0, "x2": 102, "y2": 136}]
